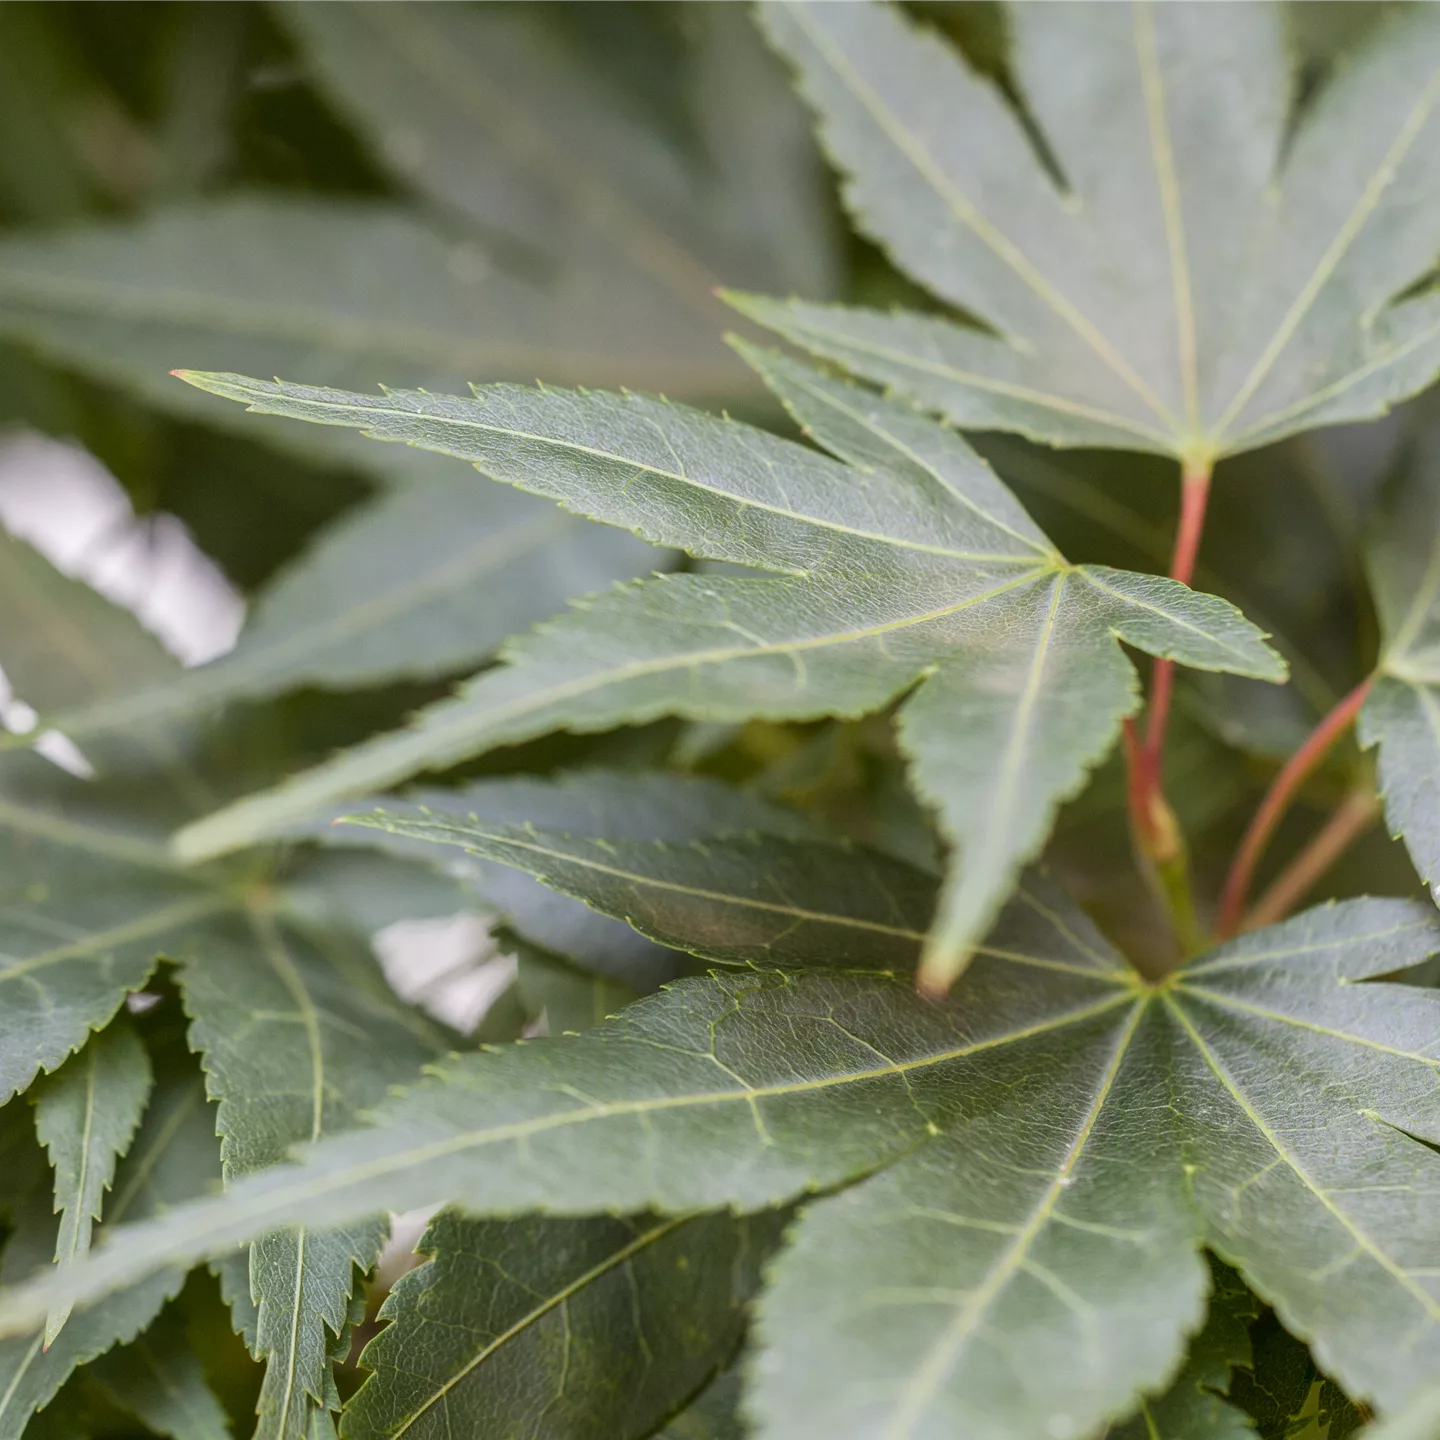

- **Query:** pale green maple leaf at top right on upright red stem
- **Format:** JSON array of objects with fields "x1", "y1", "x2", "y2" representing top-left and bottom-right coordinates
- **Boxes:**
[{"x1": 737, "y1": 0, "x2": 1440, "y2": 464}]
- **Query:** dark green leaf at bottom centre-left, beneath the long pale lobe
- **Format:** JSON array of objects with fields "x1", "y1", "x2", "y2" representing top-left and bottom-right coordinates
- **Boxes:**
[{"x1": 341, "y1": 1211, "x2": 778, "y2": 1440}]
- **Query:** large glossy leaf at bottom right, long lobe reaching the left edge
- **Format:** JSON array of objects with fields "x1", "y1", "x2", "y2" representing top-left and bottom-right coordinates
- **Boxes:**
[{"x1": 14, "y1": 894, "x2": 1440, "y2": 1440}]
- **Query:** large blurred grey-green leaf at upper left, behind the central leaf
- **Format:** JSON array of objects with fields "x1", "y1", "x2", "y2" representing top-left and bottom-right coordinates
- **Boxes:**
[{"x1": 0, "y1": 0, "x2": 835, "y2": 455}]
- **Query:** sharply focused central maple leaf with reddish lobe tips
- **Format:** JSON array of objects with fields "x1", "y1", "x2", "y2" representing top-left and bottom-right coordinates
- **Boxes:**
[{"x1": 165, "y1": 353, "x2": 1284, "y2": 988}]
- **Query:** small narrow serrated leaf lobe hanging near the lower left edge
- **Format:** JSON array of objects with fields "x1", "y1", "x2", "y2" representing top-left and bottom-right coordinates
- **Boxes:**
[{"x1": 33, "y1": 1020, "x2": 154, "y2": 1345}]
